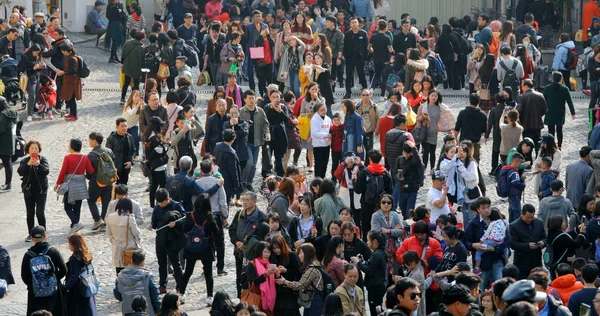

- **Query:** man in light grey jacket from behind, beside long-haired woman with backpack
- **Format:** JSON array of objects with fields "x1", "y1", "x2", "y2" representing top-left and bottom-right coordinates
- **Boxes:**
[{"x1": 196, "y1": 159, "x2": 229, "y2": 276}]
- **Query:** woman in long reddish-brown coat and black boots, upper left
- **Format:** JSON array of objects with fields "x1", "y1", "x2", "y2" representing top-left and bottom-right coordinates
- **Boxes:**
[{"x1": 57, "y1": 42, "x2": 82, "y2": 121}]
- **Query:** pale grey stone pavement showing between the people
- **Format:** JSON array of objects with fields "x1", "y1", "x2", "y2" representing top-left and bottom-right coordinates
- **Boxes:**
[{"x1": 0, "y1": 39, "x2": 588, "y2": 315}]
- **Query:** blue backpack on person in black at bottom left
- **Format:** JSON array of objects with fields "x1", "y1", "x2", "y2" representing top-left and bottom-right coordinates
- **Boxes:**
[{"x1": 27, "y1": 247, "x2": 58, "y2": 297}]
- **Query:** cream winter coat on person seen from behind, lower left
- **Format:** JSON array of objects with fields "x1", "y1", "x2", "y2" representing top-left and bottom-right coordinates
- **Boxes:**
[{"x1": 106, "y1": 212, "x2": 141, "y2": 268}]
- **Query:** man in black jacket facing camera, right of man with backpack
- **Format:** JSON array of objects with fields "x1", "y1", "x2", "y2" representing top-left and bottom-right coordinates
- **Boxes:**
[{"x1": 106, "y1": 117, "x2": 135, "y2": 185}]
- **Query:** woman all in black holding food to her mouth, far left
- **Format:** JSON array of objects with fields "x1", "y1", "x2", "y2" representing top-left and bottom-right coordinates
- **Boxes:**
[{"x1": 17, "y1": 140, "x2": 50, "y2": 242}]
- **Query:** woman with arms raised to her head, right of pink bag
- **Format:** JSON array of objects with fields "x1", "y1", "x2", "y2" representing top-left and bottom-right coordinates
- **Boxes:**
[{"x1": 278, "y1": 36, "x2": 306, "y2": 95}]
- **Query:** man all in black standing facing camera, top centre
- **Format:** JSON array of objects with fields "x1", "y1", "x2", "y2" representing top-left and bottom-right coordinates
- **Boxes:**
[{"x1": 342, "y1": 18, "x2": 369, "y2": 99}]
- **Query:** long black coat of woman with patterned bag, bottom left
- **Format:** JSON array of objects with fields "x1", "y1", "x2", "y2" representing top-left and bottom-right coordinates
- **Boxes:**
[{"x1": 65, "y1": 256, "x2": 98, "y2": 316}]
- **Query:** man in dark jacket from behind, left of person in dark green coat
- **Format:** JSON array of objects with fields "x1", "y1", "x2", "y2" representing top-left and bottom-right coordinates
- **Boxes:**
[{"x1": 513, "y1": 79, "x2": 548, "y2": 149}]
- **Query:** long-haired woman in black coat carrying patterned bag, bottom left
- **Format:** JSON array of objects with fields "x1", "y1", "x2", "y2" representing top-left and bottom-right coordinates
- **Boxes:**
[{"x1": 64, "y1": 233, "x2": 98, "y2": 316}]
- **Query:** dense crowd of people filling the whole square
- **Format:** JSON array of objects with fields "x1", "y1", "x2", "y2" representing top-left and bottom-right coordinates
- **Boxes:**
[{"x1": 0, "y1": 0, "x2": 600, "y2": 316}]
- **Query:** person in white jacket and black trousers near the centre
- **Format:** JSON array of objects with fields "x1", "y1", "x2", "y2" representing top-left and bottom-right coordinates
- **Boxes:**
[{"x1": 310, "y1": 103, "x2": 331, "y2": 179}]
